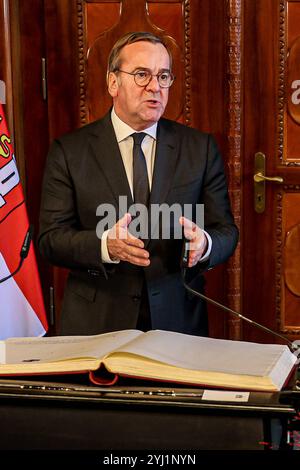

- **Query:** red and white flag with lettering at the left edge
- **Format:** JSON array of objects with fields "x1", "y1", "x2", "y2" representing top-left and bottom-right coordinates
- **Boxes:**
[{"x1": 0, "y1": 104, "x2": 48, "y2": 339}]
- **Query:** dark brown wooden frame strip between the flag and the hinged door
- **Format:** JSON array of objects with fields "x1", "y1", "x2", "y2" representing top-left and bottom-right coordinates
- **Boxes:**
[{"x1": 17, "y1": 0, "x2": 54, "y2": 333}]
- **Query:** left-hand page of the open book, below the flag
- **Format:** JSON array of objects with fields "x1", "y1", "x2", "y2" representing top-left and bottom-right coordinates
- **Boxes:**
[{"x1": 0, "y1": 330, "x2": 143, "y2": 364}]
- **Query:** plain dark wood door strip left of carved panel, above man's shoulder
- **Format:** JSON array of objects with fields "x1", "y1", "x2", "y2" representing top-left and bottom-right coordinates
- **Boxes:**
[{"x1": 44, "y1": 0, "x2": 80, "y2": 141}]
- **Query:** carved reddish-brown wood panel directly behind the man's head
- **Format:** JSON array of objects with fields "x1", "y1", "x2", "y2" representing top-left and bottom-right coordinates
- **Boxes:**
[{"x1": 77, "y1": 0, "x2": 184, "y2": 123}]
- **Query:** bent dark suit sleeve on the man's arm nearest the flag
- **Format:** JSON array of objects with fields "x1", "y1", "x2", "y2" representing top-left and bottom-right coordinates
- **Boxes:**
[{"x1": 38, "y1": 141, "x2": 106, "y2": 274}]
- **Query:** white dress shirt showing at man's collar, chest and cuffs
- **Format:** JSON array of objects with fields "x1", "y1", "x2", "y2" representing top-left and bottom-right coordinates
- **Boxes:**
[{"x1": 101, "y1": 108, "x2": 212, "y2": 263}]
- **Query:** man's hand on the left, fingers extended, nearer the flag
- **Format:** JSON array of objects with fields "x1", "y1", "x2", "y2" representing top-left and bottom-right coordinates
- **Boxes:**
[{"x1": 107, "y1": 214, "x2": 150, "y2": 266}]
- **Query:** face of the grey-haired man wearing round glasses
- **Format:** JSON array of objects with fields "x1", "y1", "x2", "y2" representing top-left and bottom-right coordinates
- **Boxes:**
[{"x1": 108, "y1": 41, "x2": 170, "y2": 131}]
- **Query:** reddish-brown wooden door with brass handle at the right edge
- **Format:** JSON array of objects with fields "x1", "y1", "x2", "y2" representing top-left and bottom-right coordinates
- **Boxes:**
[{"x1": 242, "y1": 0, "x2": 300, "y2": 342}]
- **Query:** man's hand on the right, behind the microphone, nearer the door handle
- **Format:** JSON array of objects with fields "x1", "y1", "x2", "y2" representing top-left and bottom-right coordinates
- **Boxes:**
[{"x1": 179, "y1": 217, "x2": 208, "y2": 268}]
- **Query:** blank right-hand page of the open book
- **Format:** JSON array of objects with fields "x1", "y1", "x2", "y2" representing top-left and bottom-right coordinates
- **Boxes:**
[{"x1": 113, "y1": 330, "x2": 292, "y2": 376}]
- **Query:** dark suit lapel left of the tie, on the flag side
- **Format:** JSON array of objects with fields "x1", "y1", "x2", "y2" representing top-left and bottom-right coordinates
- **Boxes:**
[{"x1": 90, "y1": 112, "x2": 133, "y2": 206}]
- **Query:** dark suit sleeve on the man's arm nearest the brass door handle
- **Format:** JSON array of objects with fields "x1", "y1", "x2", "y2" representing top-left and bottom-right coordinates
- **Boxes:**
[{"x1": 201, "y1": 136, "x2": 238, "y2": 269}]
